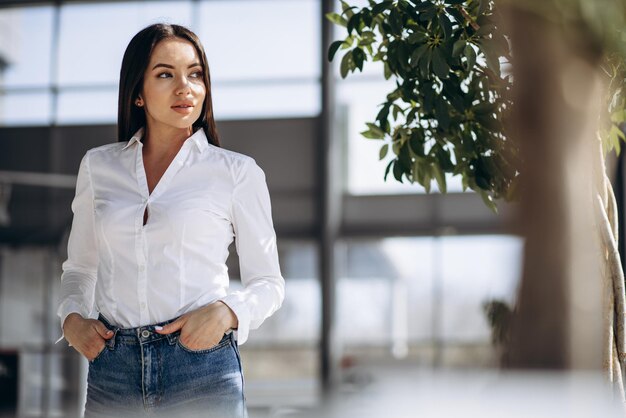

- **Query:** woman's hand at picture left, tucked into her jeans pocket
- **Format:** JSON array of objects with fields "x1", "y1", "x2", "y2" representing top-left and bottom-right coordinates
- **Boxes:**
[{"x1": 63, "y1": 313, "x2": 113, "y2": 361}]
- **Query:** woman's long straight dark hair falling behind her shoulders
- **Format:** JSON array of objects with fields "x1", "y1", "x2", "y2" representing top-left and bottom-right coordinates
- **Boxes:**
[{"x1": 117, "y1": 23, "x2": 220, "y2": 147}]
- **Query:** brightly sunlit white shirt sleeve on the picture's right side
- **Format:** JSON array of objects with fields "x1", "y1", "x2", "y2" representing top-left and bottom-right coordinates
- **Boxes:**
[{"x1": 221, "y1": 158, "x2": 285, "y2": 344}]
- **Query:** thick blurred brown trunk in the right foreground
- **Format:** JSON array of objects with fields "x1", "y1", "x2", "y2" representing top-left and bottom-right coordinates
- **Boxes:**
[{"x1": 506, "y1": 5, "x2": 604, "y2": 371}]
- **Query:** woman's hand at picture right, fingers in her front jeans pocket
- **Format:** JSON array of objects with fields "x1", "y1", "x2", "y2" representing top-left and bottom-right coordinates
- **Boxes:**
[{"x1": 156, "y1": 300, "x2": 238, "y2": 350}]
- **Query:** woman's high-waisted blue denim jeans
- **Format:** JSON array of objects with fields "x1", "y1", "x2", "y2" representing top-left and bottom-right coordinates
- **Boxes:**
[{"x1": 85, "y1": 315, "x2": 247, "y2": 418}]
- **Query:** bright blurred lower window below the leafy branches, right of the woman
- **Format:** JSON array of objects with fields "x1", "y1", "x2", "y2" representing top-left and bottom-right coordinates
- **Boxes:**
[{"x1": 337, "y1": 235, "x2": 522, "y2": 367}]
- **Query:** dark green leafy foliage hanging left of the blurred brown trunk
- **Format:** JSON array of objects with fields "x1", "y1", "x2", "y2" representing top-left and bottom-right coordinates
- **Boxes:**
[{"x1": 327, "y1": 0, "x2": 519, "y2": 211}]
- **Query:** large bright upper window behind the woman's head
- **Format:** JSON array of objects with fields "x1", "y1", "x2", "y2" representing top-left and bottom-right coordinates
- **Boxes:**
[{"x1": 0, "y1": 0, "x2": 321, "y2": 126}]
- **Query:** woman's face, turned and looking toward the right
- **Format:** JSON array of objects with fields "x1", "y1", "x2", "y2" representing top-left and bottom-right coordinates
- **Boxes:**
[{"x1": 135, "y1": 38, "x2": 206, "y2": 130}]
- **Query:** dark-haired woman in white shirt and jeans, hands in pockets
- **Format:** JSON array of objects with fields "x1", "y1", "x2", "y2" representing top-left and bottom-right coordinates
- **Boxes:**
[{"x1": 58, "y1": 24, "x2": 284, "y2": 417}]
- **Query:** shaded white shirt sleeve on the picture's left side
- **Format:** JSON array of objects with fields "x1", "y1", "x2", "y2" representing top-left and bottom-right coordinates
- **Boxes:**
[{"x1": 57, "y1": 153, "x2": 98, "y2": 342}]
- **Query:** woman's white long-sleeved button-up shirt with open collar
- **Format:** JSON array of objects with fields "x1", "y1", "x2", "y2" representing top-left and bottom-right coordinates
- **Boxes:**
[{"x1": 57, "y1": 128, "x2": 285, "y2": 344}]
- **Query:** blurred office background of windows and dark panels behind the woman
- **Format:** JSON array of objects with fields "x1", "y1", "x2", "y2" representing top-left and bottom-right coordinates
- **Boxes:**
[{"x1": 0, "y1": 0, "x2": 522, "y2": 417}]
